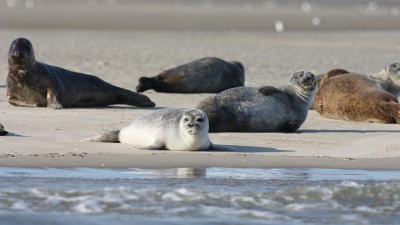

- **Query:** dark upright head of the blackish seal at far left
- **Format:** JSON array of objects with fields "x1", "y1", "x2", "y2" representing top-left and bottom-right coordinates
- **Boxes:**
[{"x1": 8, "y1": 38, "x2": 35, "y2": 69}]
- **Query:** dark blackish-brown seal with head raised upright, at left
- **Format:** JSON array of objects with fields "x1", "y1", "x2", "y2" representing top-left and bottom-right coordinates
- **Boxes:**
[{"x1": 7, "y1": 38, "x2": 155, "y2": 109}]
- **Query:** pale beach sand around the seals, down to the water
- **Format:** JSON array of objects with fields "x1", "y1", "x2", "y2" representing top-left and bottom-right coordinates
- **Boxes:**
[{"x1": 0, "y1": 29, "x2": 400, "y2": 169}]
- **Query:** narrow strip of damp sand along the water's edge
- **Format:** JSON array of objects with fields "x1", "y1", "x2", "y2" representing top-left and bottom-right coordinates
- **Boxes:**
[{"x1": 0, "y1": 155, "x2": 400, "y2": 170}]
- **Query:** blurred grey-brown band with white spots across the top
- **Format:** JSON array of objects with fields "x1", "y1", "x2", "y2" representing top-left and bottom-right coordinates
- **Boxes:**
[{"x1": 0, "y1": 0, "x2": 400, "y2": 32}]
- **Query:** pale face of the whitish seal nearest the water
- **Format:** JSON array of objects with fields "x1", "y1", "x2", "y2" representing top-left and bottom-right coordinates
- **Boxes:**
[{"x1": 179, "y1": 109, "x2": 209, "y2": 135}]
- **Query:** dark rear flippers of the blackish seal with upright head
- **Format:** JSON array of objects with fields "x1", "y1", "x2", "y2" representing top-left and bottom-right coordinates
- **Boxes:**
[{"x1": 116, "y1": 89, "x2": 156, "y2": 107}]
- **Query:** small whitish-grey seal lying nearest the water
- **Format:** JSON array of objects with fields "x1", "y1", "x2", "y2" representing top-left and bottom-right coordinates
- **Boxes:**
[{"x1": 82, "y1": 108, "x2": 235, "y2": 151}]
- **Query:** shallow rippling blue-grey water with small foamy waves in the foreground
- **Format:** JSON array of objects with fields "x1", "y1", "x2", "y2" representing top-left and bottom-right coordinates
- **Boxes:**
[{"x1": 0, "y1": 168, "x2": 400, "y2": 224}]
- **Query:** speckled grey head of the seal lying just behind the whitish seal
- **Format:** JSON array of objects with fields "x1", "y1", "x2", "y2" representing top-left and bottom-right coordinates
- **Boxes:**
[{"x1": 289, "y1": 70, "x2": 317, "y2": 92}]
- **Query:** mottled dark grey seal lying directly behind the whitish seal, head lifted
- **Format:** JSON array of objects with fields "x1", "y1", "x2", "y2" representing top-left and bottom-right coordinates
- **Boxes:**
[{"x1": 196, "y1": 71, "x2": 316, "y2": 132}]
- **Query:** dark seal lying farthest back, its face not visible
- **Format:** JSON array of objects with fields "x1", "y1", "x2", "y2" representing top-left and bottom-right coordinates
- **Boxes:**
[{"x1": 136, "y1": 57, "x2": 244, "y2": 93}]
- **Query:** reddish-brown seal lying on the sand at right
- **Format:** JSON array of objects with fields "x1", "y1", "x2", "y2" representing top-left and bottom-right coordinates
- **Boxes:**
[{"x1": 314, "y1": 68, "x2": 400, "y2": 123}]
